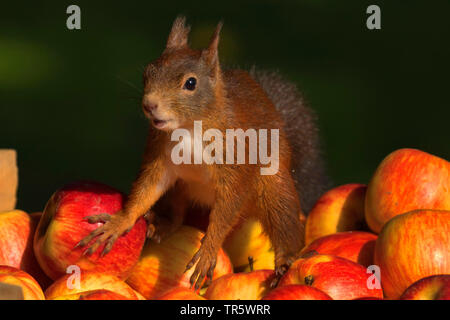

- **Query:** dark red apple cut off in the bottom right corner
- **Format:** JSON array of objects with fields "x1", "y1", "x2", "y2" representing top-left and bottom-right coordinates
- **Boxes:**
[{"x1": 400, "y1": 274, "x2": 450, "y2": 300}]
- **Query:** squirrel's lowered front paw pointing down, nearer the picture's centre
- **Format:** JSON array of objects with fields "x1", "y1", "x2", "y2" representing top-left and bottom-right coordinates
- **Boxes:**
[{"x1": 185, "y1": 245, "x2": 217, "y2": 290}]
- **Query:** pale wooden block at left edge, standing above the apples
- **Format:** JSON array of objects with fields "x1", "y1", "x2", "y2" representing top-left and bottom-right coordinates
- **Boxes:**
[{"x1": 0, "y1": 149, "x2": 19, "y2": 212}]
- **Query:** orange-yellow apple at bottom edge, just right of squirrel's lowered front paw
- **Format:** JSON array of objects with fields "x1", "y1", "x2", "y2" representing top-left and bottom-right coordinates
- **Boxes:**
[{"x1": 204, "y1": 270, "x2": 275, "y2": 300}]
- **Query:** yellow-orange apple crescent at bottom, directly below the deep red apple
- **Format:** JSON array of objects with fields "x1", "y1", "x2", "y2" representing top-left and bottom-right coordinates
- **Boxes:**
[{"x1": 45, "y1": 271, "x2": 145, "y2": 300}]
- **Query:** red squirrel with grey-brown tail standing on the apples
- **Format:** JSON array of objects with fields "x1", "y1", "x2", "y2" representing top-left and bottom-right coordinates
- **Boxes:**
[{"x1": 79, "y1": 17, "x2": 327, "y2": 289}]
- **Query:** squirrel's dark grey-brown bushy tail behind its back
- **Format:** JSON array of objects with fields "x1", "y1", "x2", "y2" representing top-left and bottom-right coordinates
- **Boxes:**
[{"x1": 250, "y1": 68, "x2": 331, "y2": 214}]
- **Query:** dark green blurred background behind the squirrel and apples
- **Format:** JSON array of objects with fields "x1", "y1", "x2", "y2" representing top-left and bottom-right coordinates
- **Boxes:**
[{"x1": 0, "y1": 0, "x2": 450, "y2": 212}]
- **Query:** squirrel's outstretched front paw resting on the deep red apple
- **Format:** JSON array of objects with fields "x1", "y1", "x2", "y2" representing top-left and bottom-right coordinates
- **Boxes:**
[{"x1": 75, "y1": 213, "x2": 133, "y2": 256}]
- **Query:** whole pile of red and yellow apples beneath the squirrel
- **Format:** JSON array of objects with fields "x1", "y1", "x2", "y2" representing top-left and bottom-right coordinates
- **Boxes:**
[{"x1": 0, "y1": 149, "x2": 450, "y2": 300}]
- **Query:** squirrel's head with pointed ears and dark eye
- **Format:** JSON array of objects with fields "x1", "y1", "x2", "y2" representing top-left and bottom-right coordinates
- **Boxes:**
[{"x1": 142, "y1": 17, "x2": 222, "y2": 131}]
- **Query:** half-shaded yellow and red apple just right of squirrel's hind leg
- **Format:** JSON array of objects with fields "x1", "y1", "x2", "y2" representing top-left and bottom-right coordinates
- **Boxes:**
[{"x1": 305, "y1": 183, "x2": 367, "y2": 245}]
